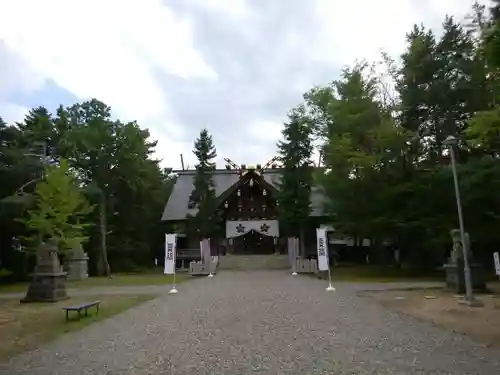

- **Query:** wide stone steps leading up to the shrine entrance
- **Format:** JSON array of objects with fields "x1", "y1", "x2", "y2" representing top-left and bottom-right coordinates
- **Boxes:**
[{"x1": 219, "y1": 254, "x2": 290, "y2": 270}]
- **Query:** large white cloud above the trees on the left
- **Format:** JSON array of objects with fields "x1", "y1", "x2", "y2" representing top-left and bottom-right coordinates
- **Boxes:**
[{"x1": 0, "y1": 0, "x2": 217, "y2": 166}]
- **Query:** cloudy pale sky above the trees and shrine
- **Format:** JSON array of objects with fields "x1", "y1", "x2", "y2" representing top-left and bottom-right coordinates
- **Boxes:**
[{"x1": 0, "y1": 0, "x2": 488, "y2": 169}]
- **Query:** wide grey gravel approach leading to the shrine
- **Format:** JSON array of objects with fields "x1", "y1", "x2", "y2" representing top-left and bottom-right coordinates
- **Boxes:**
[{"x1": 0, "y1": 271, "x2": 500, "y2": 375}]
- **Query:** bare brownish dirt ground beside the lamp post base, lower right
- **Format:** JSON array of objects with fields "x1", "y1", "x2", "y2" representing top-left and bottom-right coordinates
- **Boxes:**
[{"x1": 363, "y1": 283, "x2": 500, "y2": 347}]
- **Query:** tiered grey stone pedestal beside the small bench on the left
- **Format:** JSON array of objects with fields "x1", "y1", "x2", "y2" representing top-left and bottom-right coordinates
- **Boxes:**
[{"x1": 21, "y1": 242, "x2": 68, "y2": 302}]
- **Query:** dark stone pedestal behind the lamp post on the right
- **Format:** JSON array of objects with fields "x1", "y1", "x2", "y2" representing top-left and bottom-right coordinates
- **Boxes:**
[{"x1": 444, "y1": 260, "x2": 486, "y2": 294}]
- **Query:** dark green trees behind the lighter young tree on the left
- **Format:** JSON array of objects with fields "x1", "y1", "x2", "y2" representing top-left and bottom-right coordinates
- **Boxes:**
[{"x1": 0, "y1": 99, "x2": 175, "y2": 277}]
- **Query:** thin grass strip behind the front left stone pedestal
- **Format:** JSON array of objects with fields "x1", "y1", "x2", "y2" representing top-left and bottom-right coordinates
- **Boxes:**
[{"x1": 0, "y1": 273, "x2": 186, "y2": 293}]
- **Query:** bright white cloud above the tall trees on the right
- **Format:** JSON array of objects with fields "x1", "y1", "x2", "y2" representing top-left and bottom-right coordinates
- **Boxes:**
[{"x1": 313, "y1": 0, "x2": 491, "y2": 65}]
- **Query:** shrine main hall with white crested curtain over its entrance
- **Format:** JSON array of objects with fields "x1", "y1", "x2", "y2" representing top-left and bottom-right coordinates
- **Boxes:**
[{"x1": 162, "y1": 159, "x2": 325, "y2": 255}]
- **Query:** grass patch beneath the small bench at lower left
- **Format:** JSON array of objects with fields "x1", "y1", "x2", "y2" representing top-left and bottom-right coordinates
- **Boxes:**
[{"x1": 0, "y1": 295, "x2": 155, "y2": 362}]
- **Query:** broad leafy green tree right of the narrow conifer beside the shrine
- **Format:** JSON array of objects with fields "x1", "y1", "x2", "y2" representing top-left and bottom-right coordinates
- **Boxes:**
[{"x1": 305, "y1": 63, "x2": 416, "y2": 264}]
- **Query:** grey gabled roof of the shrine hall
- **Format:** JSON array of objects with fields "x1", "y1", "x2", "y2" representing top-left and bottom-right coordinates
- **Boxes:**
[{"x1": 161, "y1": 169, "x2": 325, "y2": 221}]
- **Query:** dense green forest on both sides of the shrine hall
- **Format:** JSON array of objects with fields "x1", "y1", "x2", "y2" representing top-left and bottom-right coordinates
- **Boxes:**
[{"x1": 0, "y1": 1, "x2": 500, "y2": 280}]
